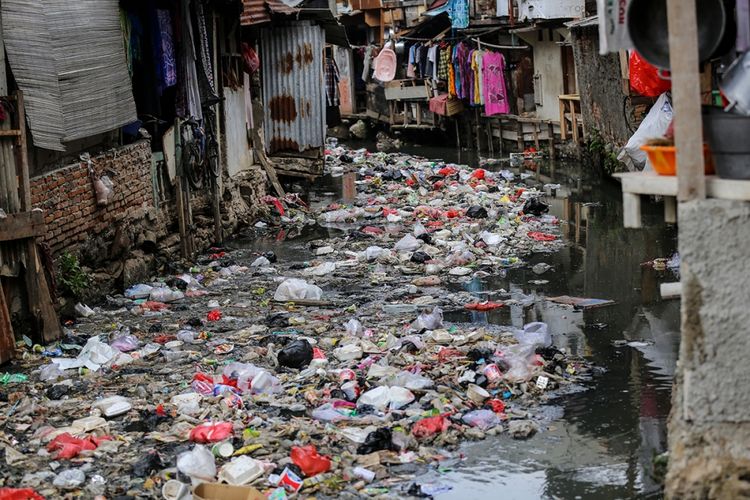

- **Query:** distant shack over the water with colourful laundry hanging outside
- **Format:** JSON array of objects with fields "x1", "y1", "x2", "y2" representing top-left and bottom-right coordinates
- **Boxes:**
[{"x1": 344, "y1": 0, "x2": 586, "y2": 151}]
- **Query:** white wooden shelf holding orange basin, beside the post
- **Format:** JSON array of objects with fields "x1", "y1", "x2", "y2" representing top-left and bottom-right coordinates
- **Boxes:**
[{"x1": 614, "y1": 172, "x2": 750, "y2": 227}]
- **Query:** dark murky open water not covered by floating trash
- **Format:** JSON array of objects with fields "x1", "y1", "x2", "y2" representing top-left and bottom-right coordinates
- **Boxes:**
[{"x1": 237, "y1": 148, "x2": 679, "y2": 499}]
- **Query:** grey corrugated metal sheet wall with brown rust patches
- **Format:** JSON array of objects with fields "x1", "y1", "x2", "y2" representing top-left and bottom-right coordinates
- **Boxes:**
[{"x1": 261, "y1": 21, "x2": 326, "y2": 153}]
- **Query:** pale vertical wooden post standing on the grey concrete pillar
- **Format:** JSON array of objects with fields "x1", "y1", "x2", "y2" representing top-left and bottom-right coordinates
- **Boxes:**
[{"x1": 667, "y1": 0, "x2": 706, "y2": 201}]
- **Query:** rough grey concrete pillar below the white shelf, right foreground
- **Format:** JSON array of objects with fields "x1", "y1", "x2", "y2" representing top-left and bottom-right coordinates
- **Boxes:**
[{"x1": 667, "y1": 199, "x2": 750, "y2": 499}]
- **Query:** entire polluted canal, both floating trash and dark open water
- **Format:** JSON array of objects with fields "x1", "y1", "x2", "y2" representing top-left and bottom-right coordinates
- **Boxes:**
[{"x1": 2, "y1": 143, "x2": 679, "y2": 498}]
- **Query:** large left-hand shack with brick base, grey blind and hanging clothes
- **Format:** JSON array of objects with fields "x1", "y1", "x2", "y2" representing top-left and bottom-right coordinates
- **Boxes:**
[{"x1": 0, "y1": 0, "x2": 265, "y2": 357}]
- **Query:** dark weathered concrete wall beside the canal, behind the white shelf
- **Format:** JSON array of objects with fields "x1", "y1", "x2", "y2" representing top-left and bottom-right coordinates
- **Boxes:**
[{"x1": 572, "y1": 26, "x2": 631, "y2": 146}]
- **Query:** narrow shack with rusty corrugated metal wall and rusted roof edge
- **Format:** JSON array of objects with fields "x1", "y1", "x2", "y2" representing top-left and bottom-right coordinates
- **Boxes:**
[{"x1": 241, "y1": 0, "x2": 349, "y2": 177}]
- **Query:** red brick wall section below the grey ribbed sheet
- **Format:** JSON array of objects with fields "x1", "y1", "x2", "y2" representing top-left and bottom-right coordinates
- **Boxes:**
[{"x1": 31, "y1": 141, "x2": 154, "y2": 255}]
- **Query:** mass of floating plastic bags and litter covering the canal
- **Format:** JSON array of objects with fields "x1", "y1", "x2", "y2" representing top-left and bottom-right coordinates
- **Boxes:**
[{"x1": 0, "y1": 148, "x2": 591, "y2": 499}]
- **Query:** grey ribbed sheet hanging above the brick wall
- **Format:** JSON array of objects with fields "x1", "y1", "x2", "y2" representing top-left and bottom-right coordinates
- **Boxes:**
[{"x1": 2, "y1": 0, "x2": 137, "y2": 150}]
